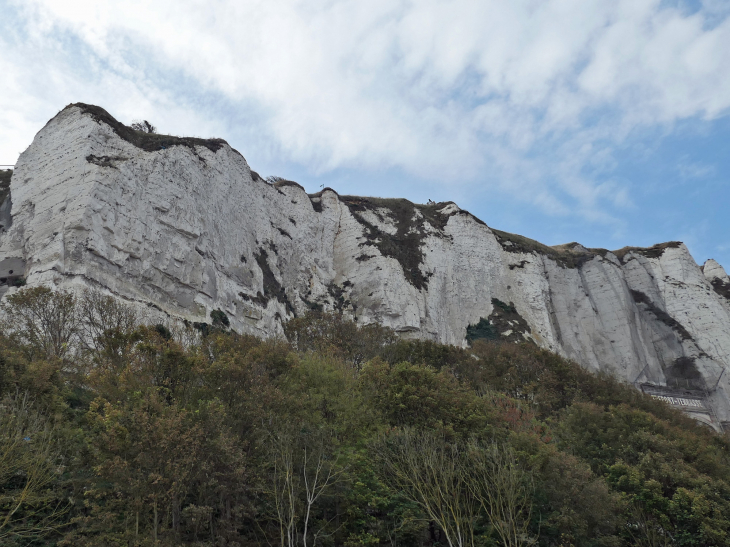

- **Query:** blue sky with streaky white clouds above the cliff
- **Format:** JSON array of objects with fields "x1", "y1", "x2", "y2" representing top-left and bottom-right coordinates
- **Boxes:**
[{"x1": 0, "y1": 0, "x2": 730, "y2": 269}]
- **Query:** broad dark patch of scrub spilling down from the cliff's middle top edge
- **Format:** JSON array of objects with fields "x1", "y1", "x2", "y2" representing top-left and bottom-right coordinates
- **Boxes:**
[{"x1": 340, "y1": 196, "x2": 451, "y2": 290}]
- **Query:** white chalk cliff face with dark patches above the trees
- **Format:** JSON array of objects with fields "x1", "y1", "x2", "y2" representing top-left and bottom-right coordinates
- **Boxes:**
[{"x1": 0, "y1": 105, "x2": 730, "y2": 422}]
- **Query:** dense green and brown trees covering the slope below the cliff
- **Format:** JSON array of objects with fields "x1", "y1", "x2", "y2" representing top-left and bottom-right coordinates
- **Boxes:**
[{"x1": 0, "y1": 288, "x2": 730, "y2": 547}]
